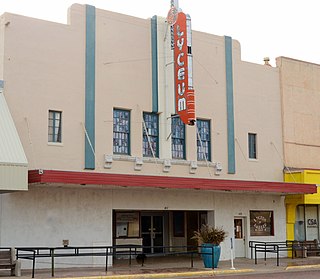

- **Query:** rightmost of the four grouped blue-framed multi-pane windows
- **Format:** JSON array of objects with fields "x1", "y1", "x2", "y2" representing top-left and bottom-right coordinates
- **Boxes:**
[{"x1": 197, "y1": 119, "x2": 211, "y2": 161}]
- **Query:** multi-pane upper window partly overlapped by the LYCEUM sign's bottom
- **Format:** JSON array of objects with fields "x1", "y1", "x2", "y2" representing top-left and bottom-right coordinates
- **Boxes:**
[{"x1": 171, "y1": 116, "x2": 186, "y2": 159}]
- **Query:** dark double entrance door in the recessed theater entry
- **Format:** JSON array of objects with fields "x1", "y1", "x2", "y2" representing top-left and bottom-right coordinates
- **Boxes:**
[{"x1": 141, "y1": 214, "x2": 164, "y2": 253}]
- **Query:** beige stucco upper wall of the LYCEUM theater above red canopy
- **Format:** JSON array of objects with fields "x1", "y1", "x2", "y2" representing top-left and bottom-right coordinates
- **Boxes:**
[{"x1": 3, "y1": 5, "x2": 282, "y2": 181}]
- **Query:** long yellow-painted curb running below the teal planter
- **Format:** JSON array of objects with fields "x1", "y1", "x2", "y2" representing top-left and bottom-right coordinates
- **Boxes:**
[{"x1": 57, "y1": 269, "x2": 255, "y2": 279}]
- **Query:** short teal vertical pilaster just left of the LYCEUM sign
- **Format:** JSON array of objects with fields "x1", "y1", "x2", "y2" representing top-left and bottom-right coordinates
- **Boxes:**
[{"x1": 151, "y1": 16, "x2": 158, "y2": 112}]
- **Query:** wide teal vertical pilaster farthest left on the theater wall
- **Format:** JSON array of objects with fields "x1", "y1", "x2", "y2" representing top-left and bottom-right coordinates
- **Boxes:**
[{"x1": 85, "y1": 5, "x2": 96, "y2": 169}]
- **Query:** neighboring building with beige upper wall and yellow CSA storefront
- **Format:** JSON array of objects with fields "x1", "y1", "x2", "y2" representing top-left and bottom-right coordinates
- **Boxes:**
[{"x1": 276, "y1": 57, "x2": 320, "y2": 245}]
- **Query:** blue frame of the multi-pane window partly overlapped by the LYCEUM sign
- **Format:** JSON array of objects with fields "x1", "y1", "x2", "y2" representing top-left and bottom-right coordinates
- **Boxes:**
[{"x1": 171, "y1": 115, "x2": 186, "y2": 160}]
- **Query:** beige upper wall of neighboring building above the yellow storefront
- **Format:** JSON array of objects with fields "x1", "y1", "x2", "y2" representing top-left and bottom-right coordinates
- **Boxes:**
[{"x1": 277, "y1": 57, "x2": 320, "y2": 169}]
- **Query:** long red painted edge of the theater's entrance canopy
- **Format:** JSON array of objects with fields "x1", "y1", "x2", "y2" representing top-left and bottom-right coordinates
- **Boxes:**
[{"x1": 28, "y1": 170, "x2": 317, "y2": 194}]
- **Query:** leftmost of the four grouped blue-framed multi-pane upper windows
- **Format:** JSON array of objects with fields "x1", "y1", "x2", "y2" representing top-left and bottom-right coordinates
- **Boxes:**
[{"x1": 113, "y1": 109, "x2": 130, "y2": 155}]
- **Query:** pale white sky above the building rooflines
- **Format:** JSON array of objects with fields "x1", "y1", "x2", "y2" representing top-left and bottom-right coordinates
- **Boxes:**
[{"x1": 0, "y1": 0, "x2": 320, "y2": 66}]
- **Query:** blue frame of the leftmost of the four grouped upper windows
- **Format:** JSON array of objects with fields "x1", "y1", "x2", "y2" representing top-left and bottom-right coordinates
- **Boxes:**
[{"x1": 112, "y1": 108, "x2": 131, "y2": 155}]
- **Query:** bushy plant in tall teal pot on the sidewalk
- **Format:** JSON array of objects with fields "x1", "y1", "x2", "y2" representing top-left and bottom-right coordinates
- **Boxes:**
[{"x1": 192, "y1": 224, "x2": 228, "y2": 268}]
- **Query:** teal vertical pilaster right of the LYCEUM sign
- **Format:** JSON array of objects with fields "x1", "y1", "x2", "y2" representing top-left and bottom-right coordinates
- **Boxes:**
[{"x1": 224, "y1": 36, "x2": 236, "y2": 174}]
